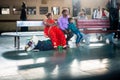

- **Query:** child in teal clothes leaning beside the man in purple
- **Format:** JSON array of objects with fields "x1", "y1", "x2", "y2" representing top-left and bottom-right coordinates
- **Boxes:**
[{"x1": 68, "y1": 18, "x2": 83, "y2": 47}]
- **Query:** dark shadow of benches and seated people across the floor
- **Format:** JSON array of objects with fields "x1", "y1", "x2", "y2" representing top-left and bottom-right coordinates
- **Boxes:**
[{"x1": 2, "y1": 45, "x2": 120, "y2": 80}]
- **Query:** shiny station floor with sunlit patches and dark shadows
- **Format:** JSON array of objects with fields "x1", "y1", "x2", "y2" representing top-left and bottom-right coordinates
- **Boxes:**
[{"x1": 0, "y1": 36, "x2": 120, "y2": 80}]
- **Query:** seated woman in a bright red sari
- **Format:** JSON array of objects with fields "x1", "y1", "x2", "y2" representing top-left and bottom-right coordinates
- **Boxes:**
[{"x1": 44, "y1": 13, "x2": 66, "y2": 49}]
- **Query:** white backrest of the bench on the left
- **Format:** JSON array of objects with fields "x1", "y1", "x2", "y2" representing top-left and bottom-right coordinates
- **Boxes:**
[{"x1": 16, "y1": 21, "x2": 44, "y2": 27}]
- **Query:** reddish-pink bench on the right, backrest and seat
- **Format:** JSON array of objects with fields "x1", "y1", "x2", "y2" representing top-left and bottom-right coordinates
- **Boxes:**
[{"x1": 77, "y1": 19, "x2": 120, "y2": 43}]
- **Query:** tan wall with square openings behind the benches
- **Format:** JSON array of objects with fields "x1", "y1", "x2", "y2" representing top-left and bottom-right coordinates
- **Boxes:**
[{"x1": 0, "y1": 0, "x2": 107, "y2": 32}]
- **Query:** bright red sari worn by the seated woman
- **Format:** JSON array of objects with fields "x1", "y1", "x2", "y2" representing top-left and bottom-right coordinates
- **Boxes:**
[{"x1": 44, "y1": 19, "x2": 66, "y2": 47}]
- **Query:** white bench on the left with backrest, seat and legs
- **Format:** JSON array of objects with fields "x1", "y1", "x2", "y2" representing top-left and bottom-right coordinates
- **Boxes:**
[{"x1": 1, "y1": 21, "x2": 44, "y2": 49}]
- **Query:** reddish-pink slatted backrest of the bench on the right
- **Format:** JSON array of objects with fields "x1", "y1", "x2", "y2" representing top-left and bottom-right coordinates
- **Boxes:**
[{"x1": 77, "y1": 20, "x2": 110, "y2": 29}]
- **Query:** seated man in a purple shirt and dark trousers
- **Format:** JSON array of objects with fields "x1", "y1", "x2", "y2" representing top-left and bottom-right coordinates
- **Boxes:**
[{"x1": 58, "y1": 9, "x2": 73, "y2": 45}]
